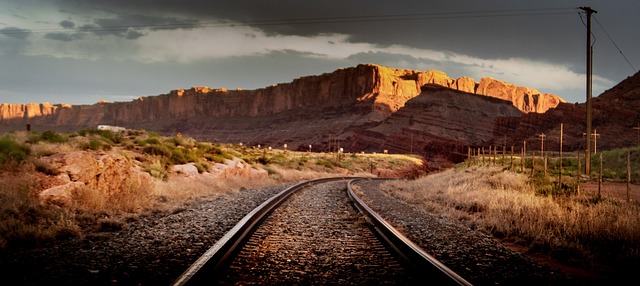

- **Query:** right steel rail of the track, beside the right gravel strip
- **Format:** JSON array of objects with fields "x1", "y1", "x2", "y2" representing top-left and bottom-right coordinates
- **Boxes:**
[{"x1": 347, "y1": 178, "x2": 472, "y2": 285}]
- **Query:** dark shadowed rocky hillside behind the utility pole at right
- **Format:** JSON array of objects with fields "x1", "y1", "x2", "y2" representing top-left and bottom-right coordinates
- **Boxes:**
[{"x1": 494, "y1": 69, "x2": 640, "y2": 151}]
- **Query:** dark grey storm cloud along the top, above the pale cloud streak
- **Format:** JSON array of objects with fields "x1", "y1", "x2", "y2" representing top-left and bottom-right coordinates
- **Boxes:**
[{"x1": 45, "y1": 0, "x2": 620, "y2": 68}]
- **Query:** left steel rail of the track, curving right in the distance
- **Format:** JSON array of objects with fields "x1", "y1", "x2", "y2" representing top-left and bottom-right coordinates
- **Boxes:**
[{"x1": 172, "y1": 177, "x2": 354, "y2": 286}]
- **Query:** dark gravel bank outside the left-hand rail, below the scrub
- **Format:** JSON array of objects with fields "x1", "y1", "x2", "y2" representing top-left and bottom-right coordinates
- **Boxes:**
[{"x1": 0, "y1": 186, "x2": 286, "y2": 285}]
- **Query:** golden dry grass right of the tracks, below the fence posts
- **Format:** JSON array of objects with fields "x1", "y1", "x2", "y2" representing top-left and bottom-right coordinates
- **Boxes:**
[{"x1": 384, "y1": 165, "x2": 640, "y2": 266}]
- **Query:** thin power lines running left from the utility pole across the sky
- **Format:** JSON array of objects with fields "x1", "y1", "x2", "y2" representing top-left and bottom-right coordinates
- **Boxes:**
[{"x1": 0, "y1": 8, "x2": 575, "y2": 35}]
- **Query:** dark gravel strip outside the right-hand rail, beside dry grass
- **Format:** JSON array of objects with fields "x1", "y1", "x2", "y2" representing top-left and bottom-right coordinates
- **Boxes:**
[{"x1": 357, "y1": 181, "x2": 579, "y2": 285}]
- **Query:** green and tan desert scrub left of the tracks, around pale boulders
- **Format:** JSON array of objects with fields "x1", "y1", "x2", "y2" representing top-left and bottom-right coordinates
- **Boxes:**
[{"x1": 0, "y1": 129, "x2": 421, "y2": 250}]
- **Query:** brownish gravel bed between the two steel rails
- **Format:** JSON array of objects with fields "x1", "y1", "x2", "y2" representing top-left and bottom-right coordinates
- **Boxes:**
[{"x1": 219, "y1": 182, "x2": 417, "y2": 286}]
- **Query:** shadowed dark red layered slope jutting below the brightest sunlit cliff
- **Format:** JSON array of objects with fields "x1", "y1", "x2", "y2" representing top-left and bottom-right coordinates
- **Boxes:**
[{"x1": 348, "y1": 85, "x2": 522, "y2": 161}]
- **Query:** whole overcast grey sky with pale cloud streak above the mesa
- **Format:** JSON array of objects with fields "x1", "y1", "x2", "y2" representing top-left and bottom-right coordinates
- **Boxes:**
[{"x1": 0, "y1": 0, "x2": 640, "y2": 104}]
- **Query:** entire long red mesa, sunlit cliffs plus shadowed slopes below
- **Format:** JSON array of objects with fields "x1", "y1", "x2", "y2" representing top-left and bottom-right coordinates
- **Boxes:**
[{"x1": 0, "y1": 64, "x2": 564, "y2": 163}]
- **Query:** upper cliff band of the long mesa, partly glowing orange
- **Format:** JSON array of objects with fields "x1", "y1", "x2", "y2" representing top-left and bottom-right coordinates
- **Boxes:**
[{"x1": 0, "y1": 65, "x2": 563, "y2": 129}]
